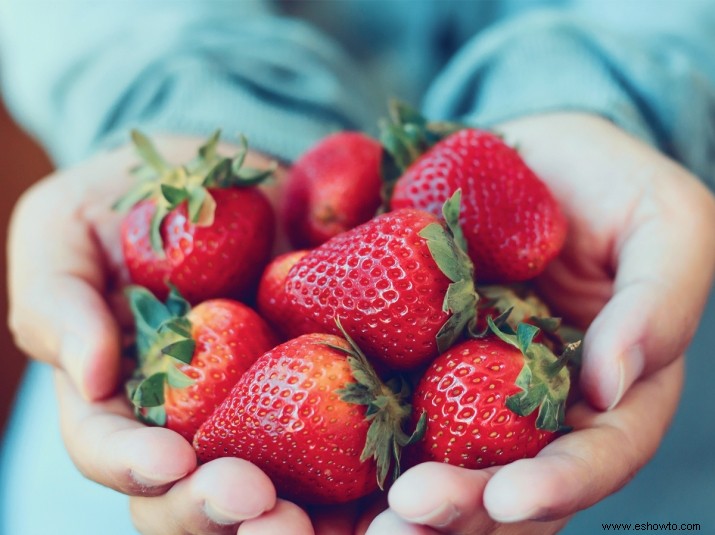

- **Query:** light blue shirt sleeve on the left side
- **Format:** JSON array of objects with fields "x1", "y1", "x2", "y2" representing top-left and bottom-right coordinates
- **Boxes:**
[{"x1": 0, "y1": 0, "x2": 376, "y2": 164}]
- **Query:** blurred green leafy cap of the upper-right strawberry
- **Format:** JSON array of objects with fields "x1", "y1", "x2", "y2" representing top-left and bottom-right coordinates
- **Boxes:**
[{"x1": 378, "y1": 99, "x2": 466, "y2": 206}]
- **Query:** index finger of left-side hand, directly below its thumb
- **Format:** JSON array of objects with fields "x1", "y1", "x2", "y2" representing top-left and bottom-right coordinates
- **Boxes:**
[{"x1": 55, "y1": 370, "x2": 196, "y2": 496}]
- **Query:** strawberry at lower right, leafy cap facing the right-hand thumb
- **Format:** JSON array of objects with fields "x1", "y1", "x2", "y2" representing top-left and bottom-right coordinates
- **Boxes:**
[{"x1": 411, "y1": 320, "x2": 576, "y2": 469}]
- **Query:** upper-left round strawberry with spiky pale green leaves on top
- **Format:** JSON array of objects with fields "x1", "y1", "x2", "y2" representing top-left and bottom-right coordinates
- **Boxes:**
[{"x1": 115, "y1": 131, "x2": 275, "y2": 303}]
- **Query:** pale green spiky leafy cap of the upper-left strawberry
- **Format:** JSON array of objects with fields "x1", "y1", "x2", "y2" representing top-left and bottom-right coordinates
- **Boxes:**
[{"x1": 113, "y1": 130, "x2": 276, "y2": 254}]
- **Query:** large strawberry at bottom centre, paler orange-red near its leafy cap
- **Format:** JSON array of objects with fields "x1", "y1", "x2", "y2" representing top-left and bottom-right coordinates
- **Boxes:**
[{"x1": 194, "y1": 327, "x2": 424, "y2": 504}]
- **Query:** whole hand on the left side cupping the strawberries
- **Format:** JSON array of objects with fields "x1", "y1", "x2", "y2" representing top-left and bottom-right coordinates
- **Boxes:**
[{"x1": 9, "y1": 138, "x2": 302, "y2": 535}]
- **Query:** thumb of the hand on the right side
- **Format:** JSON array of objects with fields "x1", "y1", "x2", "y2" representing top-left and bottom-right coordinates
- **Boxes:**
[{"x1": 581, "y1": 174, "x2": 715, "y2": 409}]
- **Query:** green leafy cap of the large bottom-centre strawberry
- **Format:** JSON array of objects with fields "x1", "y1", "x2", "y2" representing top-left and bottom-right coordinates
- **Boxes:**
[{"x1": 330, "y1": 319, "x2": 427, "y2": 489}]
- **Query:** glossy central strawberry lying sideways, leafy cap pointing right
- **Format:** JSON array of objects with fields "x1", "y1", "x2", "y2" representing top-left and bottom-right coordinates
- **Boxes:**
[{"x1": 276, "y1": 193, "x2": 477, "y2": 370}]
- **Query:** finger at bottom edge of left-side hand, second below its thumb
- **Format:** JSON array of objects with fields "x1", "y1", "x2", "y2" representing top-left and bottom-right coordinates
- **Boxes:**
[{"x1": 130, "y1": 457, "x2": 276, "y2": 535}]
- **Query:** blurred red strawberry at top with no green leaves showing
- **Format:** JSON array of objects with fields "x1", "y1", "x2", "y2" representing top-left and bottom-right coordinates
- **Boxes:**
[{"x1": 283, "y1": 132, "x2": 382, "y2": 248}]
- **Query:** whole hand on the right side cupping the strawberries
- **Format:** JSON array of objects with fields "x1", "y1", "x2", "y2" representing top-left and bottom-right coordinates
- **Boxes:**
[{"x1": 369, "y1": 114, "x2": 715, "y2": 535}]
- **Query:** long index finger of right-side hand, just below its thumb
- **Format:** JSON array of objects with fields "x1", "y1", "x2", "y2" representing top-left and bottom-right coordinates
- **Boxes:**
[{"x1": 484, "y1": 359, "x2": 684, "y2": 522}]
